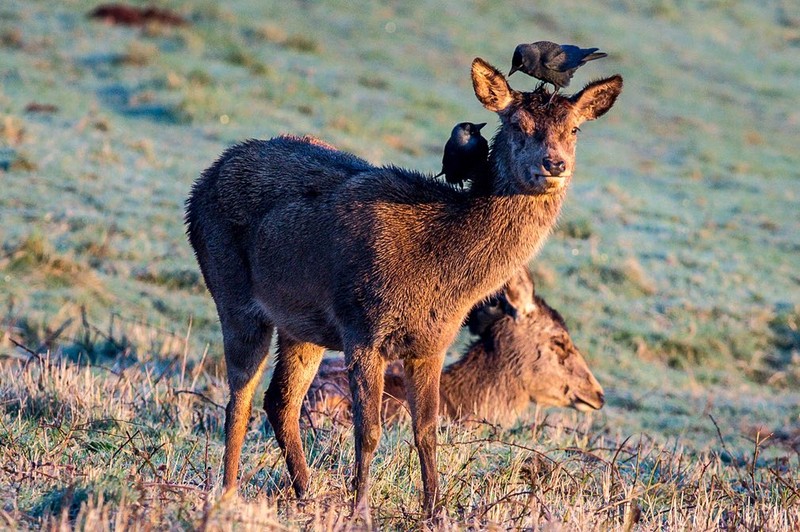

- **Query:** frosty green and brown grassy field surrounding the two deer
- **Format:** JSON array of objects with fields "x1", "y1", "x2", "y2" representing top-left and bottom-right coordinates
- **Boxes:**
[{"x1": 0, "y1": 0, "x2": 800, "y2": 530}]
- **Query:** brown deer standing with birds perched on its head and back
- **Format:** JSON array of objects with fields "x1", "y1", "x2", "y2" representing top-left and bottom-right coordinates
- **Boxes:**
[{"x1": 186, "y1": 58, "x2": 622, "y2": 519}]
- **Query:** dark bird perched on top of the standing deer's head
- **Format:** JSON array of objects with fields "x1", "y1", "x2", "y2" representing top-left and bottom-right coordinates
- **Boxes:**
[{"x1": 508, "y1": 41, "x2": 608, "y2": 95}]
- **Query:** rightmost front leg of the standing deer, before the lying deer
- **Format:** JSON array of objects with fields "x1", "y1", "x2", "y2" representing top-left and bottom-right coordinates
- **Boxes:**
[{"x1": 403, "y1": 352, "x2": 444, "y2": 517}]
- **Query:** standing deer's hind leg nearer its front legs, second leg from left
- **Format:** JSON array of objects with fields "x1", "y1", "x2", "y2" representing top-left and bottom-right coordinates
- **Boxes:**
[{"x1": 264, "y1": 331, "x2": 325, "y2": 498}]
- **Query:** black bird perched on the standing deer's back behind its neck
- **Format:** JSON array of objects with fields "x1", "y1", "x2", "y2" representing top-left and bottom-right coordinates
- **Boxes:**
[{"x1": 436, "y1": 122, "x2": 489, "y2": 188}]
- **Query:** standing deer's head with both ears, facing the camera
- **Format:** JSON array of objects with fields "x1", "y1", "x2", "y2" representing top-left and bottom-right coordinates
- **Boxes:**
[{"x1": 472, "y1": 58, "x2": 622, "y2": 195}]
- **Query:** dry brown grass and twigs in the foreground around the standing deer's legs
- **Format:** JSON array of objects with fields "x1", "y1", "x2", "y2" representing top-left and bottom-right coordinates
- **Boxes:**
[{"x1": 0, "y1": 338, "x2": 800, "y2": 530}]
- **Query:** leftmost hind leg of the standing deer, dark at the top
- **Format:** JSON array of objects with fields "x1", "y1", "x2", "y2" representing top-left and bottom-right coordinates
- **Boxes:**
[{"x1": 221, "y1": 318, "x2": 272, "y2": 494}]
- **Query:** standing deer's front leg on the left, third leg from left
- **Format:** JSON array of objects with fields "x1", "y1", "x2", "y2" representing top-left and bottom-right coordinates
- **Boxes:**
[{"x1": 346, "y1": 349, "x2": 386, "y2": 526}]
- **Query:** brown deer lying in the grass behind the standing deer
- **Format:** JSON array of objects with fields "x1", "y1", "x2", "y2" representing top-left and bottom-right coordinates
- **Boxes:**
[{"x1": 306, "y1": 267, "x2": 605, "y2": 425}]
